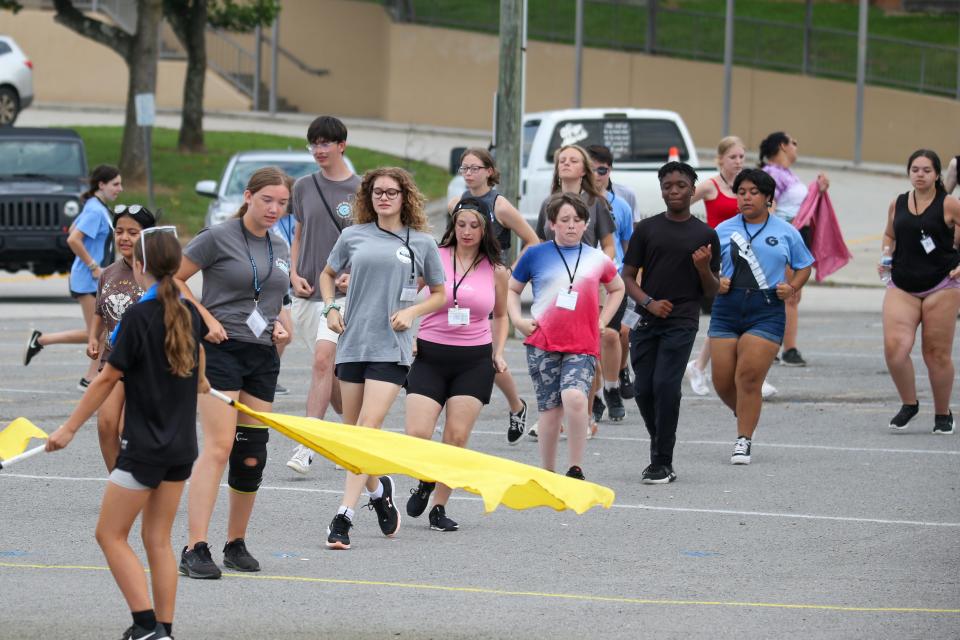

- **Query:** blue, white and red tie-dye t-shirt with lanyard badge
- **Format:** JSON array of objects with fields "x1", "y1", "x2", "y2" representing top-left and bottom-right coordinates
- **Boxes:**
[{"x1": 513, "y1": 241, "x2": 617, "y2": 357}]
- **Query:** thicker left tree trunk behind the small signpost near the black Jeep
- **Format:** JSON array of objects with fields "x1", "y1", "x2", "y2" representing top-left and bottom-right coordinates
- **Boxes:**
[{"x1": 120, "y1": 0, "x2": 162, "y2": 186}]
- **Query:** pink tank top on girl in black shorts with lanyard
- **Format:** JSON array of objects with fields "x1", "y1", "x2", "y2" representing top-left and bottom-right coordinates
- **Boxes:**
[{"x1": 417, "y1": 247, "x2": 496, "y2": 347}]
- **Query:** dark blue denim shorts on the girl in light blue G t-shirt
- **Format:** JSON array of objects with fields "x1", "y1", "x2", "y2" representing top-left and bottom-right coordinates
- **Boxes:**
[{"x1": 707, "y1": 289, "x2": 787, "y2": 344}]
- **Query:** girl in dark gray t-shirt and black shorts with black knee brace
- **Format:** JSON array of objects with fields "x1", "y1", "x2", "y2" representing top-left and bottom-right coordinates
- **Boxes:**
[{"x1": 172, "y1": 167, "x2": 290, "y2": 579}]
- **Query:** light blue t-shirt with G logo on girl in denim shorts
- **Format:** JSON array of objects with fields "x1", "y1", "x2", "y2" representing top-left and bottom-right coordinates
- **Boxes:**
[{"x1": 717, "y1": 213, "x2": 814, "y2": 289}]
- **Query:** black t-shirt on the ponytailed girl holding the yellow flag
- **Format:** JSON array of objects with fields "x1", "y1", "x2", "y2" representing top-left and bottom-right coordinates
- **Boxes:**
[{"x1": 107, "y1": 299, "x2": 207, "y2": 466}]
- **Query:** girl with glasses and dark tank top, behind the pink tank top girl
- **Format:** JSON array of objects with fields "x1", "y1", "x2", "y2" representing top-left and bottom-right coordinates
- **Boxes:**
[{"x1": 447, "y1": 147, "x2": 540, "y2": 444}]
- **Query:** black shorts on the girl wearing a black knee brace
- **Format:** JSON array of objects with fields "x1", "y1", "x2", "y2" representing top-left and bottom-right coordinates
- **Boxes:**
[{"x1": 203, "y1": 340, "x2": 280, "y2": 402}]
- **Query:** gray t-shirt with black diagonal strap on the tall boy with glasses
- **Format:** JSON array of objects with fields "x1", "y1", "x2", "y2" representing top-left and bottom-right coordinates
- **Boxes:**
[{"x1": 293, "y1": 171, "x2": 360, "y2": 300}]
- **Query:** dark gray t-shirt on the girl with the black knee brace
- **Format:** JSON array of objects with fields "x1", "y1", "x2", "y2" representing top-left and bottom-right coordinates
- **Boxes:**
[{"x1": 186, "y1": 219, "x2": 290, "y2": 345}]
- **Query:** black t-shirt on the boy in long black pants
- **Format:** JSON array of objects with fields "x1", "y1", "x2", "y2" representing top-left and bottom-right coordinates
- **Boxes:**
[{"x1": 623, "y1": 213, "x2": 720, "y2": 326}]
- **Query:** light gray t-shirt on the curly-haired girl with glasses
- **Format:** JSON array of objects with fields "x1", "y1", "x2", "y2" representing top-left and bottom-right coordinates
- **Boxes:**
[{"x1": 327, "y1": 223, "x2": 444, "y2": 366}]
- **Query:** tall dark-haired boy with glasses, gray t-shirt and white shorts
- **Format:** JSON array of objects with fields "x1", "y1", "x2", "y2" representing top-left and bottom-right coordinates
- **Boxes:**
[{"x1": 287, "y1": 116, "x2": 360, "y2": 473}]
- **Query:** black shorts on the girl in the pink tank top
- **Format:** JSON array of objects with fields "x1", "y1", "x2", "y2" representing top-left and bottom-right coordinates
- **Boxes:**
[{"x1": 407, "y1": 340, "x2": 497, "y2": 406}]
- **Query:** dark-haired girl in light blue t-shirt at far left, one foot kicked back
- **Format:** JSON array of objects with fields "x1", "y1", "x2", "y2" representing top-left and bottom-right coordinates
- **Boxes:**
[{"x1": 23, "y1": 164, "x2": 123, "y2": 392}]
